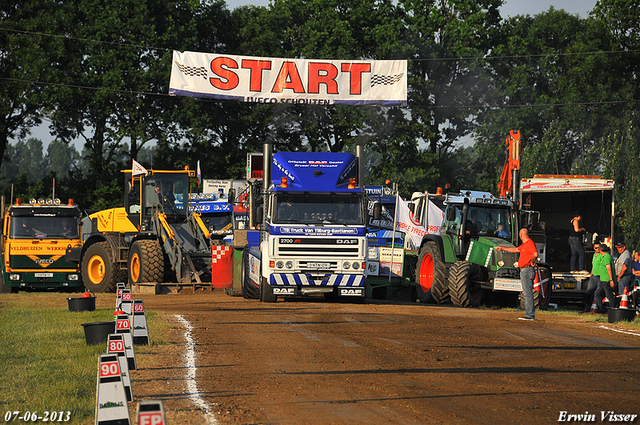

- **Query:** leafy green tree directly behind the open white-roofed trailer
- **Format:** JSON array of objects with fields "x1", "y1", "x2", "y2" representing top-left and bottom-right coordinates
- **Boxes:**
[{"x1": 475, "y1": 7, "x2": 611, "y2": 187}]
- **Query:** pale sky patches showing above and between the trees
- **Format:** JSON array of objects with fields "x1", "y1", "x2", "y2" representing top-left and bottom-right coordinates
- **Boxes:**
[{"x1": 20, "y1": 0, "x2": 597, "y2": 151}]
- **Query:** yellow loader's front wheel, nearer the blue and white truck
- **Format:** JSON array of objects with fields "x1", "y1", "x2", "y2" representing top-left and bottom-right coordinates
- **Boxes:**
[{"x1": 128, "y1": 239, "x2": 164, "y2": 283}]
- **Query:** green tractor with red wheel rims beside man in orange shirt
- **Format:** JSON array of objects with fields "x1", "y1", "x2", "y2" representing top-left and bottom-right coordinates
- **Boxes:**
[{"x1": 416, "y1": 190, "x2": 551, "y2": 307}]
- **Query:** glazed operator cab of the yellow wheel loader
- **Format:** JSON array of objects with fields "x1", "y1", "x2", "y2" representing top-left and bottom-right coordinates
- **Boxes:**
[{"x1": 125, "y1": 170, "x2": 189, "y2": 225}]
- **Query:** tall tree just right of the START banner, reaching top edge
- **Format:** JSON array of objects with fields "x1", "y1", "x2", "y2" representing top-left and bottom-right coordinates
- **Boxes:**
[{"x1": 399, "y1": 0, "x2": 501, "y2": 157}]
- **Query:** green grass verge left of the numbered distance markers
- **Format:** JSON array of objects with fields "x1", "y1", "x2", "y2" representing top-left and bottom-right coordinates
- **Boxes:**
[{"x1": 0, "y1": 292, "x2": 167, "y2": 424}]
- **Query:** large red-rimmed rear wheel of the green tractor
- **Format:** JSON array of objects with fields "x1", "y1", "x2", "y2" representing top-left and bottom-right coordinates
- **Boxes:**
[{"x1": 416, "y1": 242, "x2": 449, "y2": 304}]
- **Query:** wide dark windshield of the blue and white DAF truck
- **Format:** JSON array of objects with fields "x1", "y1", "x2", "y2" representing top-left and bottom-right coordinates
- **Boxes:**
[{"x1": 273, "y1": 194, "x2": 364, "y2": 225}]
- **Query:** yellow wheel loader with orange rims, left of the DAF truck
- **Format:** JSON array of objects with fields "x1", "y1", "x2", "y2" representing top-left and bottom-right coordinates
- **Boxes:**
[{"x1": 66, "y1": 169, "x2": 217, "y2": 292}]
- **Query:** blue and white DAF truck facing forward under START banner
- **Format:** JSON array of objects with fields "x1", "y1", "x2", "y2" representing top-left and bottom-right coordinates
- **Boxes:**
[{"x1": 241, "y1": 148, "x2": 367, "y2": 302}]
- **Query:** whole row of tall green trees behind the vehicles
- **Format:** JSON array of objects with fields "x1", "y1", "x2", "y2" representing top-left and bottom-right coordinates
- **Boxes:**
[{"x1": 0, "y1": 0, "x2": 640, "y2": 245}]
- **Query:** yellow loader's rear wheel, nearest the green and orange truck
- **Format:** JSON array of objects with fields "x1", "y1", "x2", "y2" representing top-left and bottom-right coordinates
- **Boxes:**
[{"x1": 82, "y1": 242, "x2": 120, "y2": 292}]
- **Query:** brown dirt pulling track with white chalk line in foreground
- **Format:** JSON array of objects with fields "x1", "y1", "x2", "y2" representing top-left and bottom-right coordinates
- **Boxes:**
[{"x1": 127, "y1": 292, "x2": 640, "y2": 425}]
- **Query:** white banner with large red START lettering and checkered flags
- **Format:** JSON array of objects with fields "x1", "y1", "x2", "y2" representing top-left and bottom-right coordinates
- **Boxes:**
[{"x1": 169, "y1": 50, "x2": 407, "y2": 105}]
